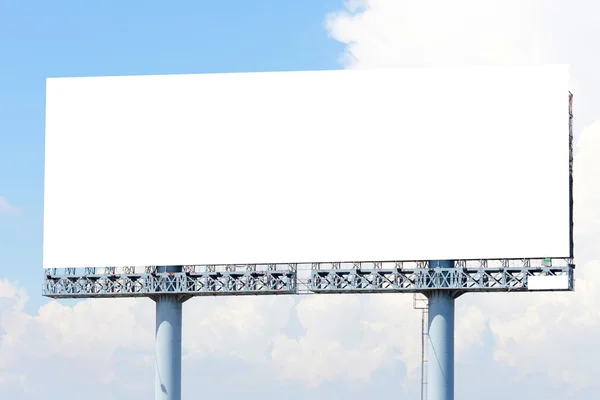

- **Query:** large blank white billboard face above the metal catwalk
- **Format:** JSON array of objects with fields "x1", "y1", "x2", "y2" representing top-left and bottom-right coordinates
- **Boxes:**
[{"x1": 43, "y1": 66, "x2": 571, "y2": 268}]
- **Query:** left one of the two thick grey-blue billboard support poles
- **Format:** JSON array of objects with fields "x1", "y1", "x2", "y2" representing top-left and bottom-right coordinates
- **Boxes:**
[{"x1": 152, "y1": 267, "x2": 187, "y2": 400}]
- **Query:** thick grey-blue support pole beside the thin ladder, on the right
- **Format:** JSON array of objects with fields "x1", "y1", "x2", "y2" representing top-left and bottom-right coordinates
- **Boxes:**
[{"x1": 427, "y1": 261, "x2": 456, "y2": 400}]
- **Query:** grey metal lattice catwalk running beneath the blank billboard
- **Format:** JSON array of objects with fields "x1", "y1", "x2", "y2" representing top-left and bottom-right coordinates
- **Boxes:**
[{"x1": 43, "y1": 259, "x2": 575, "y2": 298}]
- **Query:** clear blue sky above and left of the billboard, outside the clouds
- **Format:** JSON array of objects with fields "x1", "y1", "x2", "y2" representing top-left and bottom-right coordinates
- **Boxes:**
[{"x1": 0, "y1": 0, "x2": 343, "y2": 311}]
